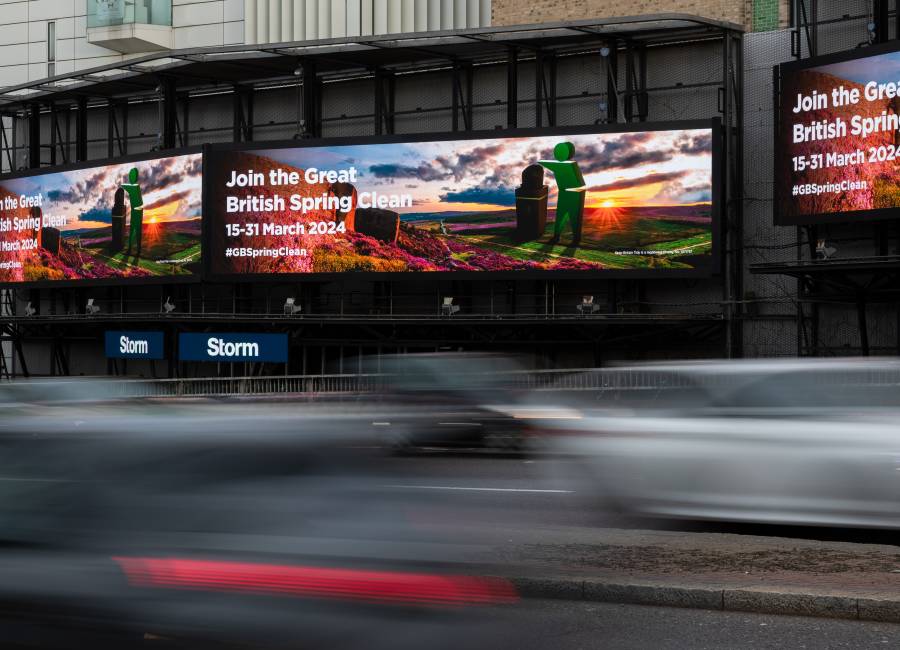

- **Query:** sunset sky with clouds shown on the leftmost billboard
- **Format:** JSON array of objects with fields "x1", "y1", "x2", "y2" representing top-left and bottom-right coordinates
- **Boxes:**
[{"x1": 0, "y1": 153, "x2": 203, "y2": 232}]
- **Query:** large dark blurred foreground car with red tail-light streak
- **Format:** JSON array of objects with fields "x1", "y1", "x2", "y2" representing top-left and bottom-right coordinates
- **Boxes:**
[{"x1": 0, "y1": 382, "x2": 517, "y2": 650}]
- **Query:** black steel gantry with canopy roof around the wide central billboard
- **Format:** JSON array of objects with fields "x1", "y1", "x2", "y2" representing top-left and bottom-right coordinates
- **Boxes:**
[{"x1": 0, "y1": 14, "x2": 743, "y2": 374}]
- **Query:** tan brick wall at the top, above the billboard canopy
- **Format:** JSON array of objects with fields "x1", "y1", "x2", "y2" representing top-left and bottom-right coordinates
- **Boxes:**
[{"x1": 491, "y1": 0, "x2": 789, "y2": 31}]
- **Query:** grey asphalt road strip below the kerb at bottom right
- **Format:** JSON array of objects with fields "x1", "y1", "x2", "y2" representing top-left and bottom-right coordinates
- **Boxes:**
[{"x1": 504, "y1": 600, "x2": 900, "y2": 650}]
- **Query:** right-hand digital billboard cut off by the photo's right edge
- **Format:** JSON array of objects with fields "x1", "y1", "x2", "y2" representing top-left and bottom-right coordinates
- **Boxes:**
[{"x1": 774, "y1": 44, "x2": 900, "y2": 225}]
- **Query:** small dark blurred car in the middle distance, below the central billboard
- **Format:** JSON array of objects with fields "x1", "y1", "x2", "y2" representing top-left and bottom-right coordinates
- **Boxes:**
[{"x1": 372, "y1": 352, "x2": 530, "y2": 451}]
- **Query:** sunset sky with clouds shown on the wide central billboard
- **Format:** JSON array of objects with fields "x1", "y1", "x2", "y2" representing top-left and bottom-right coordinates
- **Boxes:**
[{"x1": 258, "y1": 129, "x2": 712, "y2": 213}]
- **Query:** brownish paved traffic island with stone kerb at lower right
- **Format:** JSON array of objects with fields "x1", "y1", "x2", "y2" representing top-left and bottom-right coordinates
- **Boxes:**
[{"x1": 464, "y1": 528, "x2": 900, "y2": 621}]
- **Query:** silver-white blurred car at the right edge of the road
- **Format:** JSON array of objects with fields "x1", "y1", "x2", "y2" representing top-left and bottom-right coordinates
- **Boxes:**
[{"x1": 553, "y1": 359, "x2": 900, "y2": 528}]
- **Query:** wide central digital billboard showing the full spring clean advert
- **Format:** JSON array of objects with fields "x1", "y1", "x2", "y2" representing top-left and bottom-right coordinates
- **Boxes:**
[{"x1": 205, "y1": 122, "x2": 717, "y2": 279}]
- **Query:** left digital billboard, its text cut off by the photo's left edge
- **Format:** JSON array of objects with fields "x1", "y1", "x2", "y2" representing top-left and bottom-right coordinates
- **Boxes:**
[{"x1": 0, "y1": 152, "x2": 203, "y2": 284}]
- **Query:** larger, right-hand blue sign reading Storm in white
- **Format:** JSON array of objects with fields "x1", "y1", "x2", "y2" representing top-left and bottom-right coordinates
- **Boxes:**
[{"x1": 178, "y1": 333, "x2": 288, "y2": 363}]
